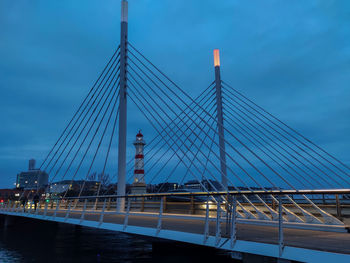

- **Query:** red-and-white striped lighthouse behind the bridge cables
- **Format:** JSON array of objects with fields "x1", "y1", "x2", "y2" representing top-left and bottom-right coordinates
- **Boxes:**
[{"x1": 131, "y1": 131, "x2": 146, "y2": 194}]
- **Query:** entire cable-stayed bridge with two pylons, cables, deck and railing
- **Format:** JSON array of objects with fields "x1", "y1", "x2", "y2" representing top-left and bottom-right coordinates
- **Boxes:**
[{"x1": 0, "y1": 0, "x2": 350, "y2": 262}]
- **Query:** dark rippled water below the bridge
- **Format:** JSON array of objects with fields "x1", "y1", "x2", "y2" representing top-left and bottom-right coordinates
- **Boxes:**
[{"x1": 0, "y1": 218, "x2": 234, "y2": 263}]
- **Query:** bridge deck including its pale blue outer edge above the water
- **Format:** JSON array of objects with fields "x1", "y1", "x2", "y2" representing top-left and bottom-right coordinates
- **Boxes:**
[{"x1": 0, "y1": 210, "x2": 350, "y2": 262}]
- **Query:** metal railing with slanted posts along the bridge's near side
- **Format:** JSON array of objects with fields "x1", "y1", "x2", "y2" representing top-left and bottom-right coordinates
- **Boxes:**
[{"x1": 0, "y1": 189, "x2": 350, "y2": 255}]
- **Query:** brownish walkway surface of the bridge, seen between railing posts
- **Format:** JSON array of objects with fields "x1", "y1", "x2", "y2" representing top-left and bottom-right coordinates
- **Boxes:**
[{"x1": 6, "y1": 210, "x2": 350, "y2": 254}]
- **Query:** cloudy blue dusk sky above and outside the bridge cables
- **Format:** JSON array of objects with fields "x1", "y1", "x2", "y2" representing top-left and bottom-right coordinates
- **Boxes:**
[{"x1": 0, "y1": 0, "x2": 350, "y2": 187}]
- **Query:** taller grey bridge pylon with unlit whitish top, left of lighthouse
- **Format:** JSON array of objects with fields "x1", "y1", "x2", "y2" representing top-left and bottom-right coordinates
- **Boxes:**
[{"x1": 117, "y1": 0, "x2": 128, "y2": 212}]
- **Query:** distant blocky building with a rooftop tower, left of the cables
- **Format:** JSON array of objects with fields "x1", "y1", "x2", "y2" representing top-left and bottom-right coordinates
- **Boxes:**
[{"x1": 16, "y1": 159, "x2": 49, "y2": 190}]
